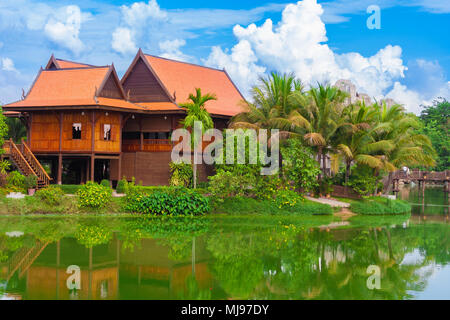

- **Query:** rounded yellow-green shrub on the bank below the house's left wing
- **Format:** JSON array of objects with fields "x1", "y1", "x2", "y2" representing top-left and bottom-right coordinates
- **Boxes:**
[{"x1": 77, "y1": 181, "x2": 112, "y2": 209}]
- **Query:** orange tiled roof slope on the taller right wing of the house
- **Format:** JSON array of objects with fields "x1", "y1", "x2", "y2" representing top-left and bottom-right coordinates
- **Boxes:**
[{"x1": 145, "y1": 55, "x2": 244, "y2": 116}]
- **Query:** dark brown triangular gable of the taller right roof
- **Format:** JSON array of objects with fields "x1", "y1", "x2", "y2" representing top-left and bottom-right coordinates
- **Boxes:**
[{"x1": 121, "y1": 51, "x2": 173, "y2": 102}]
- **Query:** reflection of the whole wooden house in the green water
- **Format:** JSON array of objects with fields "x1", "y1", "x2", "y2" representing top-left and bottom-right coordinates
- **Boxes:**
[{"x1": 0, "y1": 238, "x2": 212, "y2": 300}]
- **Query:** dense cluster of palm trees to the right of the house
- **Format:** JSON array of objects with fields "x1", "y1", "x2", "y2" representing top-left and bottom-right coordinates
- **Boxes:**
[{"x1": 230, "y1": 73, "x2": 436, "y2": 198}]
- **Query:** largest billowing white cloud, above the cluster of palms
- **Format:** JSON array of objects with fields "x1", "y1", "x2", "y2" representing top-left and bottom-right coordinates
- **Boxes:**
[{"x1": 205, "y1": 0, "x2": 446, "y2": 114}]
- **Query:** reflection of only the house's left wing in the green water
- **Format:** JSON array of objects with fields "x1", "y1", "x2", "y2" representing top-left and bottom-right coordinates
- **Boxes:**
[{"x1": 21, "y1": 238, "x2": 119, "y2": 299}]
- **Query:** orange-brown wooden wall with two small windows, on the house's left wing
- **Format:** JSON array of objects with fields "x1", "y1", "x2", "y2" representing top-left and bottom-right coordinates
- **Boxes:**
[{"x1": 30, "y1": 110, "x2": 121, "y2": 153}]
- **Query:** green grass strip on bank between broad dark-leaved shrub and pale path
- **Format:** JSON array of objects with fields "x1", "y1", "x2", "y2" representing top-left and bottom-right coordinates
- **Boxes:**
[{"x1": 213, "y1": 197, "x2": 333, "y2": 215}]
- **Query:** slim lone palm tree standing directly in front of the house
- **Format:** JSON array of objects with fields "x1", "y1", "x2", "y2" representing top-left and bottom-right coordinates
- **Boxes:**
[{"x1": 180, "y1": 88, "x2": 217, "y2": 189}]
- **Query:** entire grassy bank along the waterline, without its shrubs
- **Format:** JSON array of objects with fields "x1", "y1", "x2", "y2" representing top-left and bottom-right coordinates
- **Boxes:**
[{"x1": 0, "y1": 187, "x2": 411, "y2": 216}]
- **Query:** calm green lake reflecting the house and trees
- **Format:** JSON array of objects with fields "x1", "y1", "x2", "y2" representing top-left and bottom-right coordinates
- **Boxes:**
[{"x1": 0, "y1": 188, "x2": 450, "y2": 299}]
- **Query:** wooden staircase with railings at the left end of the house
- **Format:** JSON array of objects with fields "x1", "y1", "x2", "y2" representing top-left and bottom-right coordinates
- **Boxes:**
[{"x1": 5, "y1": 139, "x2": 52, "y2": 189}]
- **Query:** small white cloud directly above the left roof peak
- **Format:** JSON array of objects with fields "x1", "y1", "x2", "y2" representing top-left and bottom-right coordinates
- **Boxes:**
[{"x1": 44, "y1": 6, "x2": 84, "y2": 55}]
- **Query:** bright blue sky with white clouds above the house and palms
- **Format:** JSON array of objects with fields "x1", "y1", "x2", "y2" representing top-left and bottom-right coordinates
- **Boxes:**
[{"x1": 0, "y1": 0, "x2": 450, "y2": 113}]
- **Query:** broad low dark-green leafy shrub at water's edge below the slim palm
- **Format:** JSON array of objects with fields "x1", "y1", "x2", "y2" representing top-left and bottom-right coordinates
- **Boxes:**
[{"x1": 126, "y1": 188, "x2": 210, "y2": 216}]
